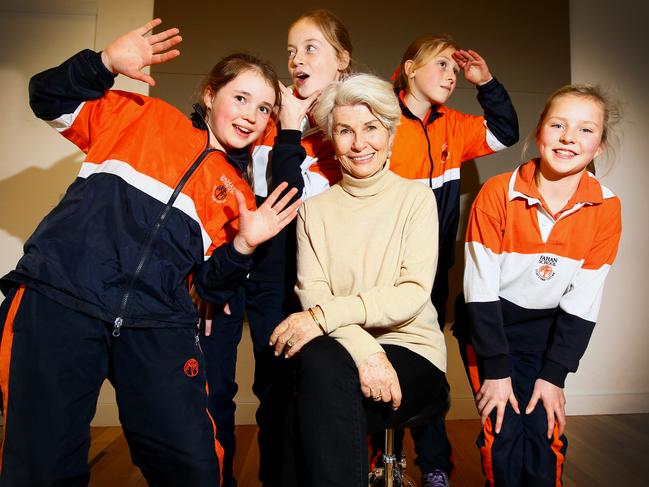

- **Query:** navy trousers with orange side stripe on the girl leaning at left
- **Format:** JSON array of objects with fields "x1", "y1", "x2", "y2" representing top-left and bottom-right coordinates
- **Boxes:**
[{"x1": 0, "y1": 288, "x2": 220, "y2": 487}]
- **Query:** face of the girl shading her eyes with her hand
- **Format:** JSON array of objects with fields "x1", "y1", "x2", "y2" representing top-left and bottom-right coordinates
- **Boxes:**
[{"x1": 404, "y1": 47, "x2": 459, "y2": 105}]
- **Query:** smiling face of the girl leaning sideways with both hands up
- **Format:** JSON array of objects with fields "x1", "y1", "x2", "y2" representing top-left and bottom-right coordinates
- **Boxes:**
[{"x1": 203, "y1": 70, "x2": 275, "y2": 152}]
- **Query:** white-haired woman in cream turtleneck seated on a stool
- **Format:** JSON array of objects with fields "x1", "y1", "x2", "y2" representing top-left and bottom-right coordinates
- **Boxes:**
[{"x1": 271, "y1": 74, "x2": 448, "y2": 487}]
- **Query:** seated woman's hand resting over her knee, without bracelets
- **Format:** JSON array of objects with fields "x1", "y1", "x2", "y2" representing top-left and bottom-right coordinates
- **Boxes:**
[{"x1": 358, "y1": 352, "x2": 402, "y2": 411}]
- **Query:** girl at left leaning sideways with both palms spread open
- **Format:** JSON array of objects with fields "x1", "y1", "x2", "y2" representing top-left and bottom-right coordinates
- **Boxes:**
[{"x1": 0, "y1": 19, "x2": 304, "y2": 486}]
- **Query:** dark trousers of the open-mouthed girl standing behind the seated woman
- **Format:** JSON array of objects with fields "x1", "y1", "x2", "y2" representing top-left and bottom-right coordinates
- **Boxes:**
[{"x1": 201, "y1": 279, "x2": 297, "y2": 487}]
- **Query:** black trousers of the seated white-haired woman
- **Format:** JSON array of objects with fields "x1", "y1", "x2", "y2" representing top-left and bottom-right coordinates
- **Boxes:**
[{"x1": 286, "y1": 336, "x2": 448, "y2": 487}]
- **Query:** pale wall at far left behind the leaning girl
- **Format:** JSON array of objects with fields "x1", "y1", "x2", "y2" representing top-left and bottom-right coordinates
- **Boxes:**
[{"x1": 0, "y1": 0, "x2": 153, "y2": 425}]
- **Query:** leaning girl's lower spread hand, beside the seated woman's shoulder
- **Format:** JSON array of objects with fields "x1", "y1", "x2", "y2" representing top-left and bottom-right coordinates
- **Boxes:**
[{"x1": 233, "y1": 182, "x2": 302, "y2": 255}]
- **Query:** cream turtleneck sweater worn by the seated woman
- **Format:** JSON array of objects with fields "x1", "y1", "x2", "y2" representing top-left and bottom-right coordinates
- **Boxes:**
[{"x1": 295, "y1": 162, "x2": 446, "y2": 371}]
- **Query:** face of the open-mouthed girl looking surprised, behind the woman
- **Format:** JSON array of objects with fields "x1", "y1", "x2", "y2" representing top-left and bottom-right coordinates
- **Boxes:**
[{"x1": 288, "y1": 19, "x2": 349, "y2": 98}]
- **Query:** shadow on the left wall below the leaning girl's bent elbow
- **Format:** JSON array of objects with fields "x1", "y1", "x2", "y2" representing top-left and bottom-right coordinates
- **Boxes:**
[{"x1": 0, "y1": 153, "x2": 83, "y2": 243}]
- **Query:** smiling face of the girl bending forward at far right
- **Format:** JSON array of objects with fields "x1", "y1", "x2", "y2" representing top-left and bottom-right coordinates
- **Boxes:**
[{"x1": 536, "y1": 95, "x2": 604, "y2": 179}]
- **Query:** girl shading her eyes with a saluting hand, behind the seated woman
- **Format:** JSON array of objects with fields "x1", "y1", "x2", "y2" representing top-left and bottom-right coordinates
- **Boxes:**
[{"x1": 390, "y1": 36, "x2": 518, "y2": 487}]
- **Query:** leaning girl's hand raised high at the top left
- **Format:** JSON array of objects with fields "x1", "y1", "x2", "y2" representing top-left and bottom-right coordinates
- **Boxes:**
[{"x1": 101, "y1": 19, "x2": 182, "y2": 86}]
